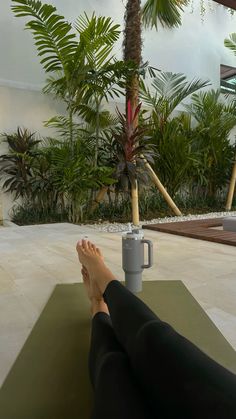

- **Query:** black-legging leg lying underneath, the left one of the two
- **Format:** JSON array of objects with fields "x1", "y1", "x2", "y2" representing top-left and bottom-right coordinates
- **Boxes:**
[{"x1": 89, "y1": 313, "x2": 151, "y2": 419}]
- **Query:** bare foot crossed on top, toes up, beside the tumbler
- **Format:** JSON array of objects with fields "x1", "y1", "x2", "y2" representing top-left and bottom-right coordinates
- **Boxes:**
[{"x1": 76, "y1": 240, "x2": 116, "y2": 295}]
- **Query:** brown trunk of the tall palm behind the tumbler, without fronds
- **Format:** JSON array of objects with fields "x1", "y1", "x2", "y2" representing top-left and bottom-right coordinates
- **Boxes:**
[{"x1": 123, "y1": 0, "x2": 142, "y2": 225}]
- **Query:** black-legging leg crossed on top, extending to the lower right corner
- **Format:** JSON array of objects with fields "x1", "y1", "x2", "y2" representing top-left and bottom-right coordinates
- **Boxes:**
[{"x1": 104, "y1": 281, "x2": 236, "y2": 419}]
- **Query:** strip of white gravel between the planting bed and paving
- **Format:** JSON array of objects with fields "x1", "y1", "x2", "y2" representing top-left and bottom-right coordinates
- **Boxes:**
[{"x1": 87, "y1": 211, "x2": 236, "y2": 233}]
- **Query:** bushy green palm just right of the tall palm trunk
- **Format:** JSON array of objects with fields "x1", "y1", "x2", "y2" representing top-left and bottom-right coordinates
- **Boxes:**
[{"x1": 141, "y1": 72, "x2": 208, "y2": 195}]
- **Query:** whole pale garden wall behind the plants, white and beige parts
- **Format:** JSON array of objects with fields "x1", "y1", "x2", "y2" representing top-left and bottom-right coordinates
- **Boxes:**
[{"x1": 0, "y1": 0, "x2": 236, "y2": 218}]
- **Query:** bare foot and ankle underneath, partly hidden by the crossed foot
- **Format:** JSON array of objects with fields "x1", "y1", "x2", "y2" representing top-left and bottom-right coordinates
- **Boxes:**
[{"x1": 81, "y1": 266, "x2": 109, "y2": 317}]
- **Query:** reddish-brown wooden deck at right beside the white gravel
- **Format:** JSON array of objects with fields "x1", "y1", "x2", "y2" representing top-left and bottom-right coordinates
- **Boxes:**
[{"x1": 143, "y1": 218, "x2": 236, "y2": 246}]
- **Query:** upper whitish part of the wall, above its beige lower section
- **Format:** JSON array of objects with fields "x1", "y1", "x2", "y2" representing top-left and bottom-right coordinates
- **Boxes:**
[{"x1": 0, "y1": 0, "x2": 236, "y2": 87}]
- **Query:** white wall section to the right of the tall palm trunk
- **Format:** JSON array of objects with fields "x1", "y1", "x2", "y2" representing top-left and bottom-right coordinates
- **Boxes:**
[{"x1": 144, "y1": 0, "x2": 236, "y2": 88}]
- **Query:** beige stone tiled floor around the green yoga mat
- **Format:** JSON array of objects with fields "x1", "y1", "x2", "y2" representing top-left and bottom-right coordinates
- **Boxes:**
[{"x1": 0, "y1": 223, "x2": 236, "y2": 385}]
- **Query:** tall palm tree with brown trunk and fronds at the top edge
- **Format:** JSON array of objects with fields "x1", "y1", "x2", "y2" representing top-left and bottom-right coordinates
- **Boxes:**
[{"x1": 124, "y1": 0, "x2": 189, "y2": 225}]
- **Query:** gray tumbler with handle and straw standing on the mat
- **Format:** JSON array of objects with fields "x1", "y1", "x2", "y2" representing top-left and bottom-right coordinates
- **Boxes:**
[{"x1": 122, "y1": 229, "x2": 153, "y2": 293}]
